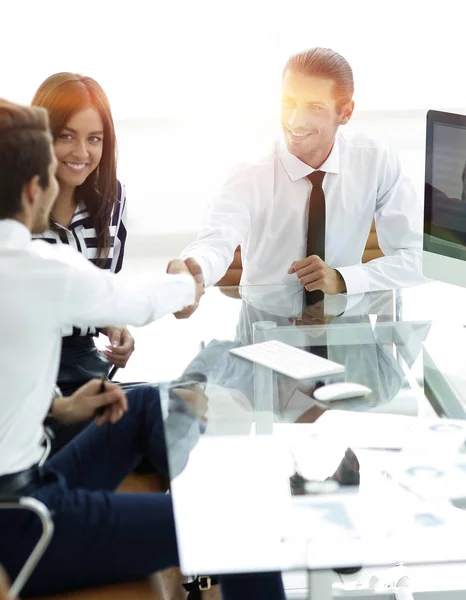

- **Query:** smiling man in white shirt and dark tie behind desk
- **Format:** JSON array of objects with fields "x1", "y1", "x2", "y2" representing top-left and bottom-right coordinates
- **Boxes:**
[{"x1": 180, "y1": 48, "x2": 423, "y2": 316}]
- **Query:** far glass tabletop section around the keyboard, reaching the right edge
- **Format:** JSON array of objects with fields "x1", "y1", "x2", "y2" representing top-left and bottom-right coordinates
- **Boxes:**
[{"x1": 118, "y1": 282, "x2": 466, "y2": 419}]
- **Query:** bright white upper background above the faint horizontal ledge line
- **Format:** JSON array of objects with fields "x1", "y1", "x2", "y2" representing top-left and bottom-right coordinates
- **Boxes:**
[{"x1": 6, "y1": 0, "x2": 466, "y2": 116}]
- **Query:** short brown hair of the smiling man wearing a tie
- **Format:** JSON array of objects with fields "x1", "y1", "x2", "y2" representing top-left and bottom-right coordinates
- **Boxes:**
[{"x1": 283, "y1": 48, "x2": 354, "y2": 108}]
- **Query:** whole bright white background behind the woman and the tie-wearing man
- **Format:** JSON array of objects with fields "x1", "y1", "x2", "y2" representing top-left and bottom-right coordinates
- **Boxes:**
[{"x1": 0, "y1": 0, "x2": 466, "y2": 241}]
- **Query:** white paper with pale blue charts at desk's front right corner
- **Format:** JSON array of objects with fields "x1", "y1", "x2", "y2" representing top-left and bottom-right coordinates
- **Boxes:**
[{"x1": 284, "y1": 492, "x2": 466, "y2": 569}]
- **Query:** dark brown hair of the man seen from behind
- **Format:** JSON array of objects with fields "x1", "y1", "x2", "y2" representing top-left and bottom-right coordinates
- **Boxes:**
[{"x1": 0, "y1": 98, "x2": 52, "y2": 219}]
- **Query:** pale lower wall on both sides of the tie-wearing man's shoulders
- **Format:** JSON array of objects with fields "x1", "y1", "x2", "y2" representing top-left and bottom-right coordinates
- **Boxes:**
[{"x1": 117, "y1": 111, "x2": 432, "y2": 253}]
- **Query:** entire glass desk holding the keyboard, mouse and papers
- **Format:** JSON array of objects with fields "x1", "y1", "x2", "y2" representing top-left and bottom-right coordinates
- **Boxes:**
[{"x1": 124, "y1": 286, "x2": 466, "y2": 600}]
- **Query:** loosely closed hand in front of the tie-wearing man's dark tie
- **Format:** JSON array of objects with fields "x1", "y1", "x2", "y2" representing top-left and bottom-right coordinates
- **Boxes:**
[{"x1": 288, "y1": 255, "x2": 346, "y2": 294}]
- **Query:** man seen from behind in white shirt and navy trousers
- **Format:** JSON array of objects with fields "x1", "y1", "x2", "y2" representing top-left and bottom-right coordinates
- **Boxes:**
[{"x1": 0, "y1": 100, "x2": 284, "y2": 600}]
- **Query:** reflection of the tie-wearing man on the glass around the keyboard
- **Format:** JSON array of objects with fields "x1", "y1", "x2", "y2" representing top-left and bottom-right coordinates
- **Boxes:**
[{"x1": 165, "y1": 286, "x2": 430, "y2": 428}]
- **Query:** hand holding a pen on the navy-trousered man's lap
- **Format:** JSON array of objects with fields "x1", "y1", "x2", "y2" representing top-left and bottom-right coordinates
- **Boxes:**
[{"x1": 52, "y1": 379, "x2": 128, "y2": 425}]
